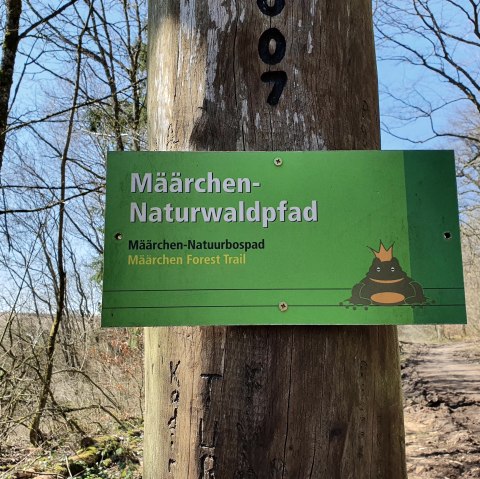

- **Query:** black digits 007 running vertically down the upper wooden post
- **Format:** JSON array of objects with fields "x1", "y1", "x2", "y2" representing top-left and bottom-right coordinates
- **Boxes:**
[{"x1": 257, "y1": 0, "x2": 287, "y2": 106}]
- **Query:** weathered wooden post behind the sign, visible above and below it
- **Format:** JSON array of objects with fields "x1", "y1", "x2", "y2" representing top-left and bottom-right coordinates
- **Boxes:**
[{"x1": 143, "y1": 0, "x2": 406, "y2": 479}]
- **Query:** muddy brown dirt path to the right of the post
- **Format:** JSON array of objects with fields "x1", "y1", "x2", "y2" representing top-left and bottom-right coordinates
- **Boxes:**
[{"x1": 402, "y1": 342, "x2": 480, "y2": 479}]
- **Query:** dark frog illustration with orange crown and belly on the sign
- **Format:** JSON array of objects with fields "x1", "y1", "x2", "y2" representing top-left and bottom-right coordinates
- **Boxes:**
[{"x1": 348, "y1": 241, "x2": 427, "y2": 306}]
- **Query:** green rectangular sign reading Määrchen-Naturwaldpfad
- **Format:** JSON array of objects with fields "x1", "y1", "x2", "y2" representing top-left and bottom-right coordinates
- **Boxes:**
[{"x1": 102, "y1": 151, "x2": 466, "y2": 326}]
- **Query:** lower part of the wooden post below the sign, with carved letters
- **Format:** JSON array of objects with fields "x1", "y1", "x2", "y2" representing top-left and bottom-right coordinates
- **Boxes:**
[{"x1": 144, "y1": 326, "x2": 406, "y2": 479}]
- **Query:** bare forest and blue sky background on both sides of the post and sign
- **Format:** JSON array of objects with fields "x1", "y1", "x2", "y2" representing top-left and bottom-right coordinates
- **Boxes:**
[{"x1": 0, "y1": 0, "x2": 480, "y2": 477}]
